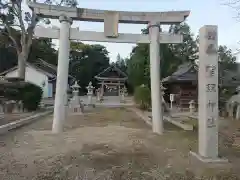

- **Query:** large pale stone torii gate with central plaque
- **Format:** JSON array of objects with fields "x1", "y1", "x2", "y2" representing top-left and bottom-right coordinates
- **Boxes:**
[{"x1": 28, "y1": 2, "x2": 190, "y2": 134}]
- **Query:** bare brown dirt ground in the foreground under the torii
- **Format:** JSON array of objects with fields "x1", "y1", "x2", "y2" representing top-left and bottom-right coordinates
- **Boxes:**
[{"x1": 0, "y1": 108, "x2": 240, "y2": 180}]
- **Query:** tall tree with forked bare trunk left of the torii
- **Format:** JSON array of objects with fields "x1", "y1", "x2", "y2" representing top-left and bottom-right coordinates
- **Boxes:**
[{"x1": 0, "y1": 0, "x2": 77, "y2": 79}]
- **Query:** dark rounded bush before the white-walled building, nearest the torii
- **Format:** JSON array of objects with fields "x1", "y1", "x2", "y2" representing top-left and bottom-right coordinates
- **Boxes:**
[{"x1": 20, "y1": 83, "x2": 43, "y2": 111}]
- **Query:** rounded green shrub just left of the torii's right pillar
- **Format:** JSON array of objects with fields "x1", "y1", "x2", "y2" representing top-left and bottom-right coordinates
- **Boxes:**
[{"x1": 134, "y1": 85, "x2": 151, "y2": 110}]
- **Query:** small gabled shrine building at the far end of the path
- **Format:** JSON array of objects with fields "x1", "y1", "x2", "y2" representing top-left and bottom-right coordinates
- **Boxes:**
[{"x1": 95, "y1": 64, "x2": 128, "y2": 96}]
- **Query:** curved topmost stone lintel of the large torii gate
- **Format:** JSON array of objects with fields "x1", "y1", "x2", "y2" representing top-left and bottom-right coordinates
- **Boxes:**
[{"x1": 27, "y1": 0, "x2": 190, "y2": 24}]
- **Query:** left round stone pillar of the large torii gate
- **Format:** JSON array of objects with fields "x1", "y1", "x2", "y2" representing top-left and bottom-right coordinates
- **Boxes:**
[{"x1": 52, "y1": 15, "x2": 72, "y2": 133}]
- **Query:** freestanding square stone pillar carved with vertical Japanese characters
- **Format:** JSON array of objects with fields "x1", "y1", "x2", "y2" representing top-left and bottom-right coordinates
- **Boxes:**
[{"x1": 191, "y1": 25, "x2": 226, "y2": 162}]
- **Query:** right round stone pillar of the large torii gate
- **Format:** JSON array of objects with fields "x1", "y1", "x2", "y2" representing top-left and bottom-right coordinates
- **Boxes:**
[{"x1": 148, "y1": 22, "x2": 163, "y2": 134}]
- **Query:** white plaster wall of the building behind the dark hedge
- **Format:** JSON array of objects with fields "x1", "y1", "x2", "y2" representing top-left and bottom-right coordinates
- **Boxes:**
[{"x1": 5, "y1": 67, "x2": 48, "y2": 98}]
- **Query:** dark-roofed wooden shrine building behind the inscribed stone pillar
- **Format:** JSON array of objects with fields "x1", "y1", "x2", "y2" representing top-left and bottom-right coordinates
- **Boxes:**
[{"x1": 162, "y1": 62, "x2": 240, "y2": 108}]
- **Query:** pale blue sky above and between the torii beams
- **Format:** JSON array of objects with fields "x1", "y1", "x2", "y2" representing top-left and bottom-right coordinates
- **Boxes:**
[{"x1": 32, "y1": 0, "x2": 240, "y2": 61}]
